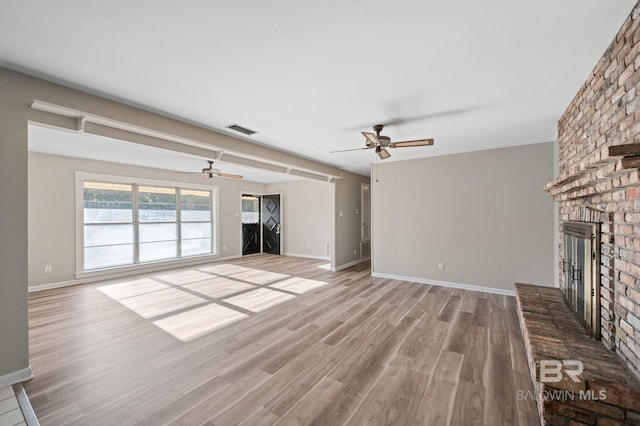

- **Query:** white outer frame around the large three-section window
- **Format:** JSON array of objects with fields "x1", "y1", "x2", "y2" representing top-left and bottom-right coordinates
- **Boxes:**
[{"x1": 75, "y1": 171, "x2": 220, "y2": 278}]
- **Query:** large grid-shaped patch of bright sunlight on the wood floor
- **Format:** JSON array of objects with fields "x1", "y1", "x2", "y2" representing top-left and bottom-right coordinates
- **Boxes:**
[{"x1": 96, "y1": 263, "x2": 327, "y2": 342}]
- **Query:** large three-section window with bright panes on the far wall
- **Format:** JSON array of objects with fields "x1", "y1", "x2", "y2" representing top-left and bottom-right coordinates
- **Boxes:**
[{"x1": 78, "y1": 174, "x2": 215, "y2": 272}]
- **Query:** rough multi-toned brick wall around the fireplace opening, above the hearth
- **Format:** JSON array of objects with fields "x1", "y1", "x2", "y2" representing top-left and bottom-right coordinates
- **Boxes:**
[{"x1": 546, "y1": 3, "x2": 640, "y2": 376}]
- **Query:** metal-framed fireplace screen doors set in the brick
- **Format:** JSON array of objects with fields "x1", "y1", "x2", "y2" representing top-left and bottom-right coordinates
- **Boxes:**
[{"x1": 562, "y1": 222, "x2": 600, "y2": 339}]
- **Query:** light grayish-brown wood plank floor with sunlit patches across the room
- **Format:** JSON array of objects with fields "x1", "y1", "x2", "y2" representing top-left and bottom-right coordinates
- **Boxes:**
[{"x1": 26, "y1": 255, "x2": 538, "y2": 426}]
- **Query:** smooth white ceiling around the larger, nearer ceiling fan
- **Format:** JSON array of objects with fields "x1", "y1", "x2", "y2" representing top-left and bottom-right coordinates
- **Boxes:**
[{"x1": 0, "y1": 0, "x2": 635, "y2": 174}]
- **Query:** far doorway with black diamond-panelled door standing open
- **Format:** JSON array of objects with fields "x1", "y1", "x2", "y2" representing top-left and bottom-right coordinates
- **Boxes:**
[{"x1": 242, "y1": 194, "x2": 282, "y2": 256}]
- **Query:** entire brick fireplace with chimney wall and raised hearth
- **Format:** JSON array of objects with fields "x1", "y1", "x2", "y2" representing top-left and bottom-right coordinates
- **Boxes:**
[{"x1": 516, "y1": 2, "x2": 640, "y2": 425}]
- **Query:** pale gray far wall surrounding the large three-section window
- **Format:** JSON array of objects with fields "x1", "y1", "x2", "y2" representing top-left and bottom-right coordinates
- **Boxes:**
[{"x1": 29, "y1": 152, "x2": 265, "y2": 286}]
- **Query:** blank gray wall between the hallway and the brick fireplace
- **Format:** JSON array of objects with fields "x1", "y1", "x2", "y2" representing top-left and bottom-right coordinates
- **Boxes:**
[{"x1": 372, "y1": 143, "x2": 554, "y2": 290}]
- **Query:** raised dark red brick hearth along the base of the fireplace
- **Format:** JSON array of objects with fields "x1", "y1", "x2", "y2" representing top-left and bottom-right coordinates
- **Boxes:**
[{"x1": 516, "y1": 284, "x2": 640, "y2": 426}]
